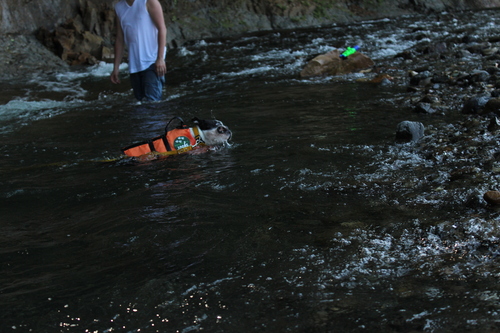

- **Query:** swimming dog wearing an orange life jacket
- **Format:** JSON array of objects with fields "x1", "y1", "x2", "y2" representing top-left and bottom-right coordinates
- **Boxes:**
[{"x1": 122, "y1": 117, "x2": 232, "y2": 160}]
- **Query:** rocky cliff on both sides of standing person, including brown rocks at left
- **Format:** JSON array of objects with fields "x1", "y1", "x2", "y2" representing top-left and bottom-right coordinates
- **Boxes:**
[{"x1": 0, "y1": 0, "x2": 500, "y2": 73}]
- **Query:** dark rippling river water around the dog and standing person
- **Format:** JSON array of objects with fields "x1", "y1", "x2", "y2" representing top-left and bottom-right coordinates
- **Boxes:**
[{"x1": 0, "y1": 11, "x2": 500, "y2": 333}]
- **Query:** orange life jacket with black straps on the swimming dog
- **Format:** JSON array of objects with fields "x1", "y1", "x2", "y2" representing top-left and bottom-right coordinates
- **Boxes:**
[{"x1": 122, "y1": 126, "x2": 205, "y2": 156}]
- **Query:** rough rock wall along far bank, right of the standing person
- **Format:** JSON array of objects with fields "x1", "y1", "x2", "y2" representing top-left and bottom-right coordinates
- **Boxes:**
[{"x1": 164, "y1": 0, "x2": 500, "y2": 46}]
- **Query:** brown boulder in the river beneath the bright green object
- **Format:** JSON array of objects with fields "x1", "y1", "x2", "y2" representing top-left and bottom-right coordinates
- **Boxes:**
[{"x1": 300, "y1": 50, "x2": 374, "y2": 77}]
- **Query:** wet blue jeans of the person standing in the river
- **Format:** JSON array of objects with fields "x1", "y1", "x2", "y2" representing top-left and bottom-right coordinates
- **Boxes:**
[{"x1": 130, "y1": 64, "x2": 165, "y2": 102}]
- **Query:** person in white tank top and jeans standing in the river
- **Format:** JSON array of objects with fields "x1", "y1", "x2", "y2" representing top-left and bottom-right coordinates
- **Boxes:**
[{"x1": 111, "y1": 0, "x2": 167, "y2": 101}]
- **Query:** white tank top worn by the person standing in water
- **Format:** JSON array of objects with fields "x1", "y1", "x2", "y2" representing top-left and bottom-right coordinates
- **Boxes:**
[{"x1": 115, "y1": 0, "x2": 164, "y2": 74}]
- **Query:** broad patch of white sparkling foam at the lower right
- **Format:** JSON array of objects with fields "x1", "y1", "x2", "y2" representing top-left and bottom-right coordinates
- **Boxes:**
[{"x1": 286, "y1": 218, "x2": 499, "y2": 290}]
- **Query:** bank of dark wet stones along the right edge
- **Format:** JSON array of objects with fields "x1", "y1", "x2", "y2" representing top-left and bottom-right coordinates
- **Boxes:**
[{"x1": 360, "y1": 16, "x2": 500, "y2": 208}]
